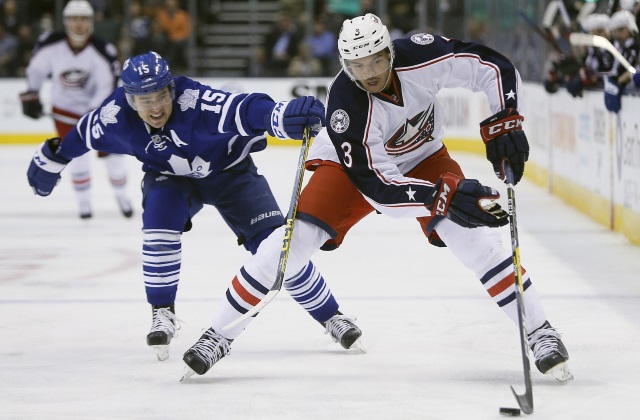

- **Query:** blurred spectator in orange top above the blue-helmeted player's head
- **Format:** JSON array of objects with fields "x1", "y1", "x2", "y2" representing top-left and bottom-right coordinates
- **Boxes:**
[{"x1": 156, "y1": 0, "x2": 191, "y2": 73}]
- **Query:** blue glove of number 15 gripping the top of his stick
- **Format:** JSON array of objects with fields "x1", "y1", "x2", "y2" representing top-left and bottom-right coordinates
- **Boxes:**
[{"x1": 264, "y1": 96, "x2": 325, "y2": 140}]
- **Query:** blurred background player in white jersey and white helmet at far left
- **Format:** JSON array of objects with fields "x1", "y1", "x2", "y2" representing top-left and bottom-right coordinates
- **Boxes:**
[{"x1": 20, "y1": 0, "x2": 133, "y2": 219}]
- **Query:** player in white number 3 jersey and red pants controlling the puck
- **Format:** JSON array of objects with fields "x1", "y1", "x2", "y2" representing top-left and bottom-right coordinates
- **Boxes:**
[{"x1": 183, "y1": 14, "x2": 572, "y2": 382}]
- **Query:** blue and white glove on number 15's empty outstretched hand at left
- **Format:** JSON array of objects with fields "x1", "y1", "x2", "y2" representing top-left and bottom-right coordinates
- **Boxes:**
[{"x1": 27, "y1": 137, "x2": 69, "y2": 197}]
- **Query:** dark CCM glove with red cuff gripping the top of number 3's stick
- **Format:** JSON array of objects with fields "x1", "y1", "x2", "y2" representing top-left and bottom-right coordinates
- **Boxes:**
[{"x1": 480, "y1": 108, "x2": 529, "y2": 185}]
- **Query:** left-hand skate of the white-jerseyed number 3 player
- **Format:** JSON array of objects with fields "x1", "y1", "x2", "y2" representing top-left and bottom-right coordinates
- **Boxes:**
[{"x1": 180, "y1": 328, "x2": 233, "y2": 382}]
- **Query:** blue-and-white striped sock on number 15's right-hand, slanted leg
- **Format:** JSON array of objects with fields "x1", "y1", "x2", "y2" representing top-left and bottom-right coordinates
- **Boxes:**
[{"x1": 284, "y1": 261, "x2": 338, "y2": 323}]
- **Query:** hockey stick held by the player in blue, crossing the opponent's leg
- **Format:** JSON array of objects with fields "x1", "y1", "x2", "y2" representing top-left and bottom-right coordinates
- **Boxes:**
[{"x1": 222, "y1": 126, "x2": 311, "y2": 331}]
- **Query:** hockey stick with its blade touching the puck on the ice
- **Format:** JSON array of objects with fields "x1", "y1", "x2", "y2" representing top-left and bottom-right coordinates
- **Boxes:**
[{"x1": 504, "y1": 165, "x2": 533, "y2": 414}]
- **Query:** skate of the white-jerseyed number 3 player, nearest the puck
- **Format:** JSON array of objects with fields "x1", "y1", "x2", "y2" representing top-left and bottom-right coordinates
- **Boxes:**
[{"x1": 529, "y1": 321, "x2": 573, "y2": 383}]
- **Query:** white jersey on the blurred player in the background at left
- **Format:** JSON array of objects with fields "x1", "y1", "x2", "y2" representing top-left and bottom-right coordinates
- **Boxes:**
[{"x1": 26, "y1": 32, "x2": 120, "y2": 115}]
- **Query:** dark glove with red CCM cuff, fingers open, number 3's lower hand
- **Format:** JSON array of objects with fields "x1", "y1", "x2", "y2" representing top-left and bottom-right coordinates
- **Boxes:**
[{"x1": 425, "y1": 172, "x2": 509, "y2": 228}]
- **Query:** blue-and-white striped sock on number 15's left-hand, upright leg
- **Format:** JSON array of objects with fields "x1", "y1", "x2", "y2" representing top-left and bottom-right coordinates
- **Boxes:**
[{"x1": 142, "y1": 229, "x2": 182, "y2": 306}]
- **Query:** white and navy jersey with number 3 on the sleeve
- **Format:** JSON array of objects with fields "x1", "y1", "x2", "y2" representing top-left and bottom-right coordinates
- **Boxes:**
[{"x1": 308, "y1": 33, "x2": 521, "y2": 217}]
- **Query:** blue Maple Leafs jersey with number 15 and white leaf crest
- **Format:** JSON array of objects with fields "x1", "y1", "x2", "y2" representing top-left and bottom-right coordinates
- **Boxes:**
[{"x1": 58, "y1": 77, "x2": 275, "y2": 178}]
